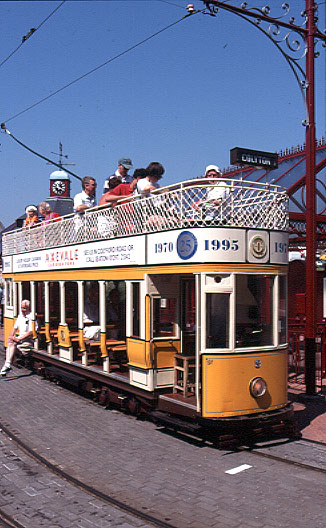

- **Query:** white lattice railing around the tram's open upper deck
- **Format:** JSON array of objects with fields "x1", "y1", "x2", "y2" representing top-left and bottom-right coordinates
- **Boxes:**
[{"x1": 2, "y1": 178, "x2": 288, "y2": 256}]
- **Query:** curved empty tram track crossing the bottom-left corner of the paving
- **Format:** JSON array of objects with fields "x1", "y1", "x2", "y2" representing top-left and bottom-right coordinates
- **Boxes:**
[{"x1": 0, "y1": 422, "x2": 178, "y2": 528}]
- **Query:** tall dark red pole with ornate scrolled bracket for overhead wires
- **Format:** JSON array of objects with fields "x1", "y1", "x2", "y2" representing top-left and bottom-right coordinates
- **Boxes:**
[{"x1": 202, "y1": 0, "x2": 326, "y2": 395}]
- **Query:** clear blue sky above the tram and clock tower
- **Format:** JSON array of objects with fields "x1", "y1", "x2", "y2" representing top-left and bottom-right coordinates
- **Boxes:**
[{"x1": 0, "y1": 0, "x2": 326, "y2": 225}]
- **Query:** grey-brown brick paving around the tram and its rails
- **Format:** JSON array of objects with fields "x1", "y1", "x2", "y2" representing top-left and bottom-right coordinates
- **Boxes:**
[{"x1": 0, "y1": 336, "x2": 326, "y2": 528}]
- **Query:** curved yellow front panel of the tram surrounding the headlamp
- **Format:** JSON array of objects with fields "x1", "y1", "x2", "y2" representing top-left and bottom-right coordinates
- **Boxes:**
[{"x1": 202, "y1": 350, "x2": 287, "y2": 418}]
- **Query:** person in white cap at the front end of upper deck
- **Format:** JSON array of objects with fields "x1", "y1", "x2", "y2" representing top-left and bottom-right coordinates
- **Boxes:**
[{"x1": 194, "y1": 165, "x2": 230, "y2": 220}]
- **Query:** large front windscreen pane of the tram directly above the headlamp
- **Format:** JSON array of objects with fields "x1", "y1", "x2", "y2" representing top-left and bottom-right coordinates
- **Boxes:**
[{"x1": 236, "y1": 275, "x2": 274, "y2": 348}]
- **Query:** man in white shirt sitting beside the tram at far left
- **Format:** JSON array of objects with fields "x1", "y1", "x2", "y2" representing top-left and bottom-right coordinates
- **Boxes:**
[{"x1": 0, "y1": 300, "x2": 36, "y2": 376}]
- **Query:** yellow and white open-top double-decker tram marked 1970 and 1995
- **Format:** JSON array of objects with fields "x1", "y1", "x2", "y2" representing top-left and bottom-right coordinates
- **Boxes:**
[{"x1": 3, "y1": 180, "x2": 292, "y2": 444}]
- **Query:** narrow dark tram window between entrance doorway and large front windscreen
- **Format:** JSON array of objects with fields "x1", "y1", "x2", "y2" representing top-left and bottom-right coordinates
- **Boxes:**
[{"x1": 206, "y1": 293, "x2": 230, "y2": 348}]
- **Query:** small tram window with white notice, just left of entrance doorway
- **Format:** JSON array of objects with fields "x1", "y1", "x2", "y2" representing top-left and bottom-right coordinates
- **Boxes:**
[{"x1": 153, "y1": 297, "x2": 177, "y2": 337}]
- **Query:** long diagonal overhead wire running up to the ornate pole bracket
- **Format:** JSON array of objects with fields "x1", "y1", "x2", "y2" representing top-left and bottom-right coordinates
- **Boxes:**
[{"x1": 3, "y1": 11, "x2": 202, "y2": 123}]
